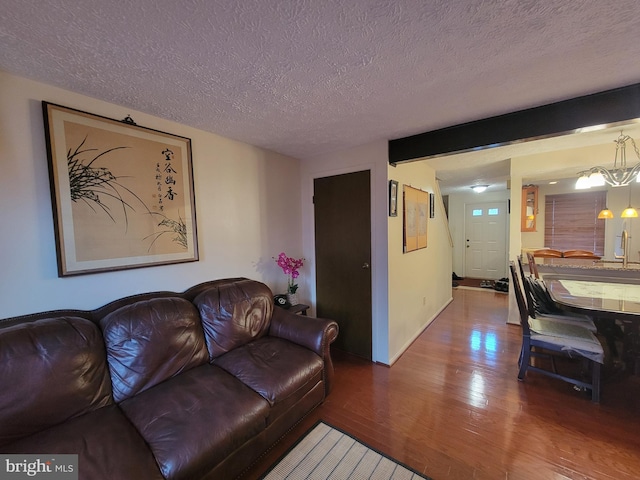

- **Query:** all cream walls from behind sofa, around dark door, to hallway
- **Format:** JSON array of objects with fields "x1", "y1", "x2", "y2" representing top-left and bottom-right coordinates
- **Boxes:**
[{"x1": 0, "y1": 72, "x2": 458, "y2": 364}]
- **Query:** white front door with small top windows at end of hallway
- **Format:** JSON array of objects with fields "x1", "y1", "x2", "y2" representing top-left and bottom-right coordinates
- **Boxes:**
[{"x1": 465, "y1": 202, "x2": 508, "y2": 280}]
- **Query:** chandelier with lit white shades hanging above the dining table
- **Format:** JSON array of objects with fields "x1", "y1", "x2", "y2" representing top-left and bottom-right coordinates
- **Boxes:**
[{"x1": 576, "y1": 132, "x2": 640, "y2": 190}]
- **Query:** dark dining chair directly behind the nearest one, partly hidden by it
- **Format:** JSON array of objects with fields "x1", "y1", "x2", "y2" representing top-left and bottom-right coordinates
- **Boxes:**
[{"x1": 518, "y1": 257, "x2": 598, "y2": 333}]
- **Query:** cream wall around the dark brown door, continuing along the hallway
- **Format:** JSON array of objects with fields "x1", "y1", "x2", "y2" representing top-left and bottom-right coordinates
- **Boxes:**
[{"x1": 302, "y1": 146, "x2": 451, "y2": 365}]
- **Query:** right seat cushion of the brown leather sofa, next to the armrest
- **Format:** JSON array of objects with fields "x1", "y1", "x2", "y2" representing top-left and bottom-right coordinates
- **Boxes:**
[{"x1": 214, "y1": 336, "x2": 323, "y2": 416}]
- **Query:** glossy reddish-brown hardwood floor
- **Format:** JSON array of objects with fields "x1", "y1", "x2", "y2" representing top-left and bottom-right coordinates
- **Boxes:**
[{"x1": 243, "y1": 289, "x2": 640, "y2": 480}]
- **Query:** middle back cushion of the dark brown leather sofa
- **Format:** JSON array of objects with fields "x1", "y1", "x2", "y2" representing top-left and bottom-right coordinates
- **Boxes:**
[{"x1": 100, "y1": 297, "x2": 208, "y2": 403}]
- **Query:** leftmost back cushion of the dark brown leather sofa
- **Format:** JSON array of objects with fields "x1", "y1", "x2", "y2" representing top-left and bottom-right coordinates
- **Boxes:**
[{"x1": 0, "y1": 316, "x2": 113, "y2": 445}]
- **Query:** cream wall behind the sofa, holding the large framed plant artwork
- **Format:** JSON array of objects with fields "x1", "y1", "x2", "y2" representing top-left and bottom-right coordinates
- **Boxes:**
[{"x1": 0, "y1": 72, "x2": 302, "y2": 318}]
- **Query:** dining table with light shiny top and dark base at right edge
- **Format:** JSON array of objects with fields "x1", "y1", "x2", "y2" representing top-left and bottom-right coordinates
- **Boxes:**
[{"x1": 542, "y1": 273, "x2": 640, "y2": 375}]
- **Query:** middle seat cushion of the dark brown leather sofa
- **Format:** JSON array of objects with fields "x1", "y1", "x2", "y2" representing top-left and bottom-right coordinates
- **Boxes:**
[{"x1": 120, "y1": 364, "x2": 269, "y2": 479}]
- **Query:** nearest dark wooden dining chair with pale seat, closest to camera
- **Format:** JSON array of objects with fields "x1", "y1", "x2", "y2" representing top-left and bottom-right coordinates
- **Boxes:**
[{"x1": 509, "y1": 261, "x2": 604, "y2": 403}]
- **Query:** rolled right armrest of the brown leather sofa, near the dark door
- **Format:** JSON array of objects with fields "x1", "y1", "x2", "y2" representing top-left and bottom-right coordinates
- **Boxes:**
[{"x1": 269, "y1": 307, "x2": 338, "y2": 395}]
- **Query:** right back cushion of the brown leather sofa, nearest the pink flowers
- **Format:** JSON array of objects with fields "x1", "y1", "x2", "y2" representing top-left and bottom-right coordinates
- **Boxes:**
[{"x1": 193, "y1": 279, "x2": 274, "y2": 360}]
